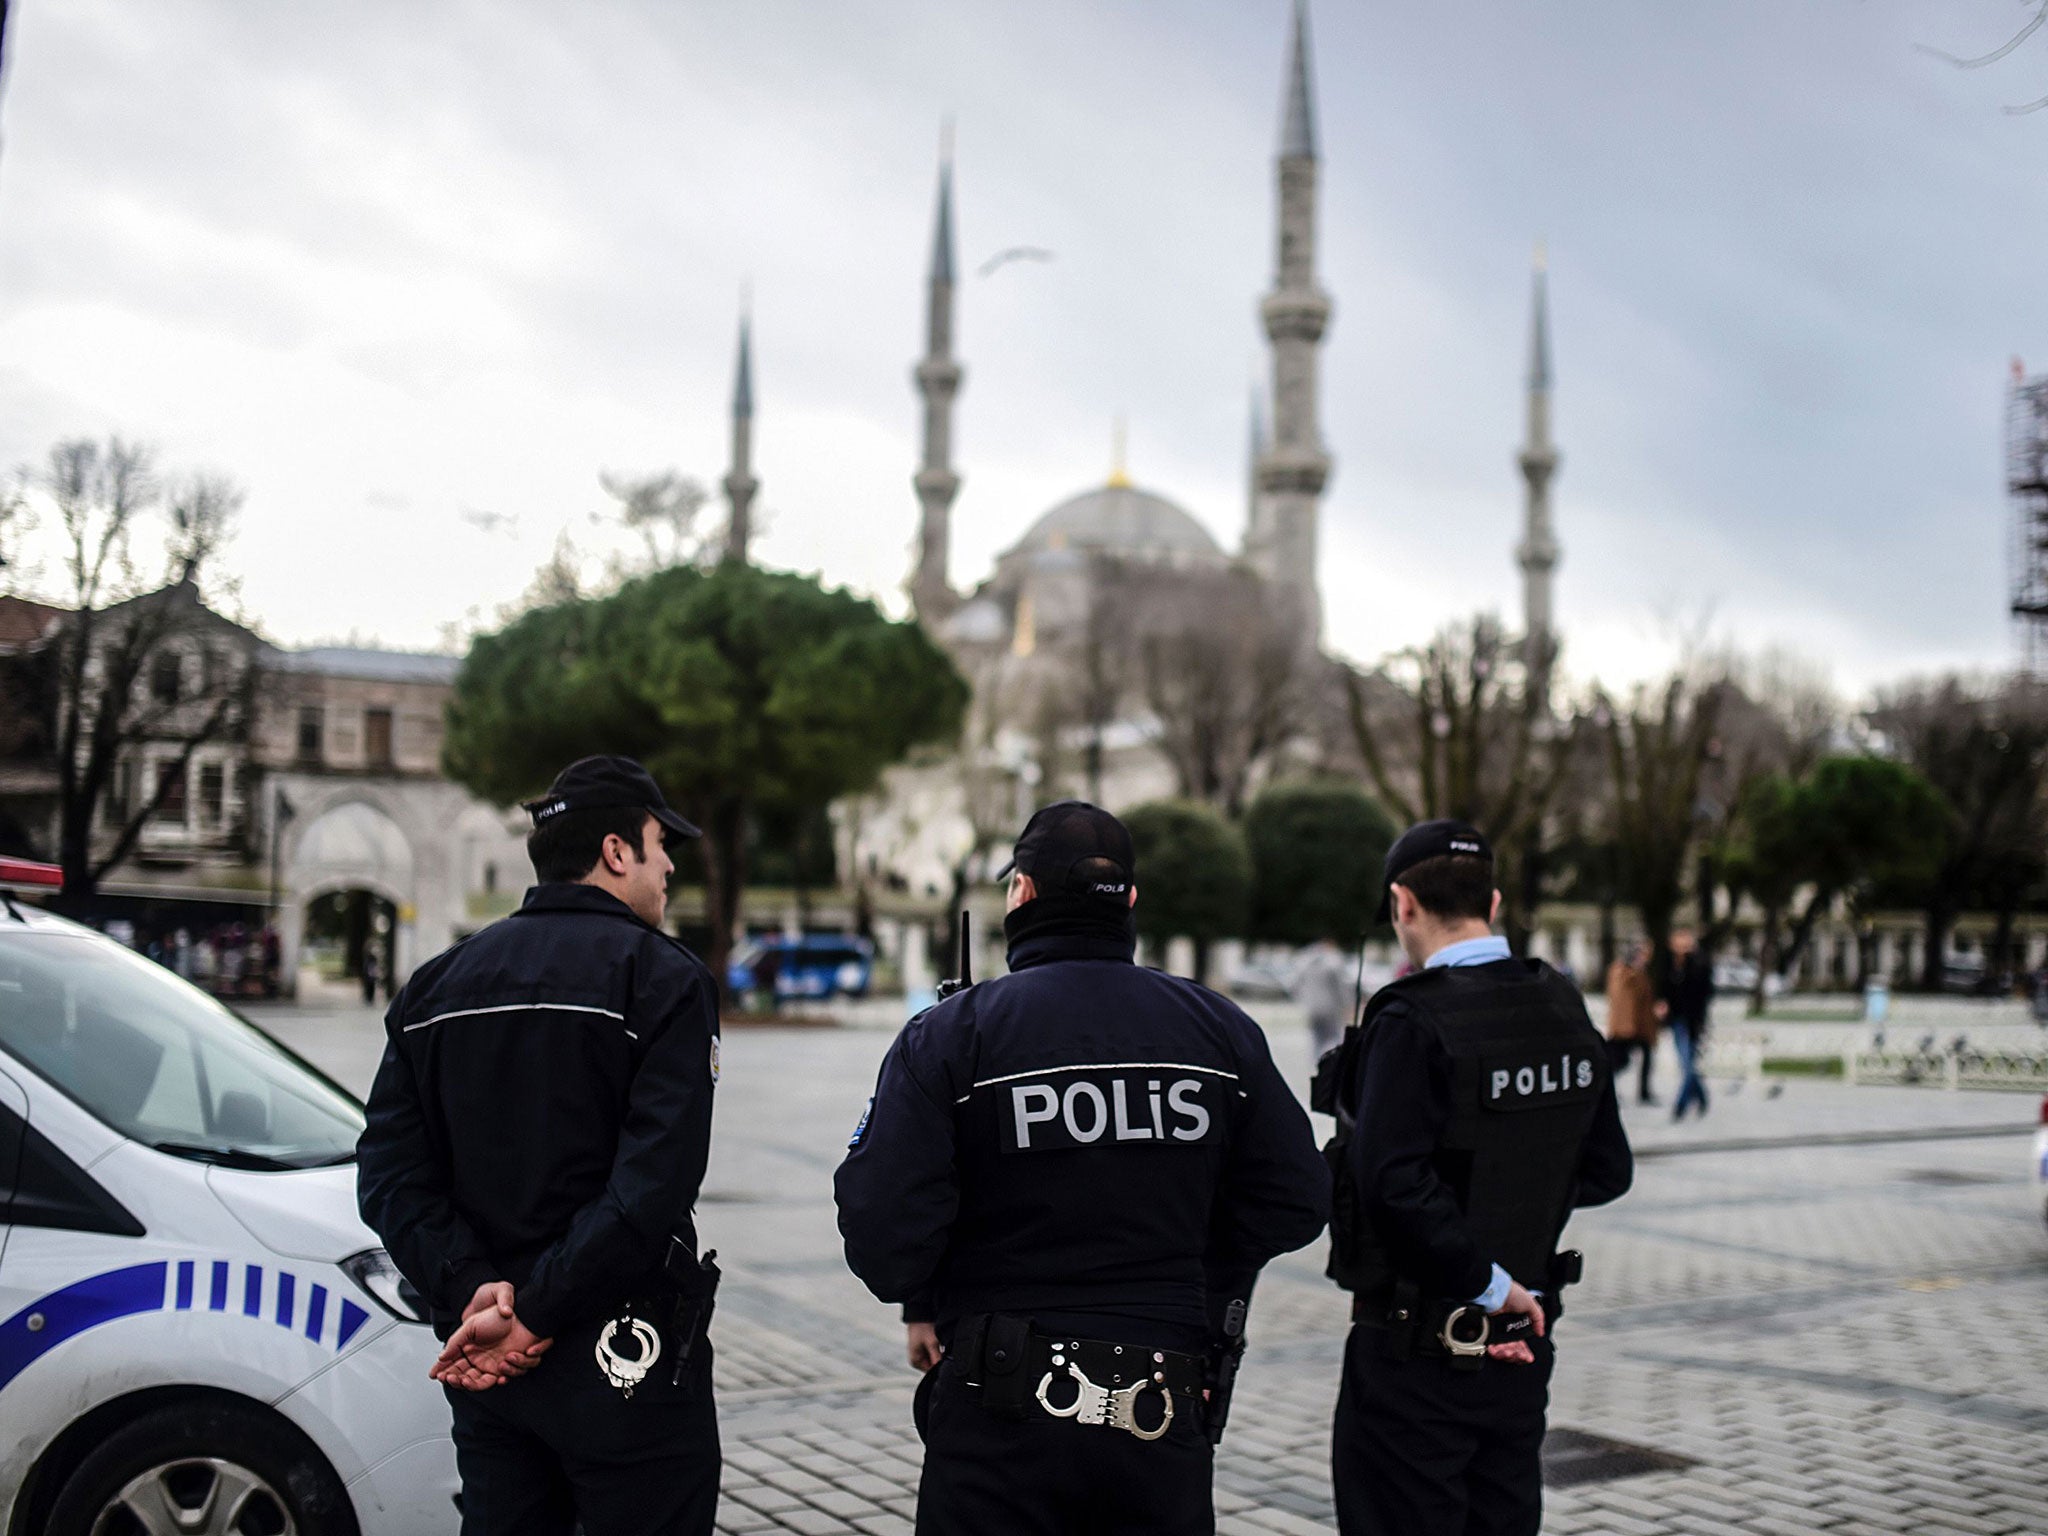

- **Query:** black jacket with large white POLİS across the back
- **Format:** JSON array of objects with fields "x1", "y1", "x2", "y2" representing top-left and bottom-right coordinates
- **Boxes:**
[{"x1": 836, "y1": 897, "x2": 1329, "y2": 1350}]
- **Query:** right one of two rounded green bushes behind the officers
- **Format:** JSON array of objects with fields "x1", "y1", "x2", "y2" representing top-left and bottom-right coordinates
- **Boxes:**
[{"x1": 1245, "y1": 782, "x2": 1395, "y2": 948}]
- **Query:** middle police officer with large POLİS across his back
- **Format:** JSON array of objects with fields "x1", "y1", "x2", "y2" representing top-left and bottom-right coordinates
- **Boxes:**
[{"x1": 836, "y1": 801, "x2": 1329, "y2": 1536}]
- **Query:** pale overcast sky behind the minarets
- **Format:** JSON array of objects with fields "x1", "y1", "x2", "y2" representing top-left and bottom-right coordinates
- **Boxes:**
[{"x1": 0, "y1": 0, "x2": 2048, "y2": 690}]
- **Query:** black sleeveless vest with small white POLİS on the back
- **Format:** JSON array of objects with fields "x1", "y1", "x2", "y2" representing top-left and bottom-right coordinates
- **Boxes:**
[{"x1": 1315, "y1": 961, "x2": 1610, "y2": 1296}]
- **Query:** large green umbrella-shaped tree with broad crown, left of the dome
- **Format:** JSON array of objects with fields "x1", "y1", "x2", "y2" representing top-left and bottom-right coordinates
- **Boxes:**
[{"x1": 442, "y1": 563, "x2": 967, "y2": 999}]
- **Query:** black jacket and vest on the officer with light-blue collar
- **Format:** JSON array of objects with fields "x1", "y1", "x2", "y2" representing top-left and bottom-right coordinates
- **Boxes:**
[{"x1": 1343, "y1": 961, "x2": 1634, "y2": 1300}]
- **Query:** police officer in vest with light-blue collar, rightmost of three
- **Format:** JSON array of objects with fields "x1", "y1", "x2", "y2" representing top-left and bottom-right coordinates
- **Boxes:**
[{"x1": 1315, "y1": 821, "x2": 1632, "y2": 1536}]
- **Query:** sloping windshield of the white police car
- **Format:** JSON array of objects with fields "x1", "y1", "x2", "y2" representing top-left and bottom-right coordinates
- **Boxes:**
[{"x1": 0, "y1": 930, "x2": 362, "y2": 1169}]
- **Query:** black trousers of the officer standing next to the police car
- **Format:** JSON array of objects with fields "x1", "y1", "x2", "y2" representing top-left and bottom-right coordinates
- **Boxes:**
[{"x1": 444, "y1": 1329, "x2": 719, "y2": 1536}]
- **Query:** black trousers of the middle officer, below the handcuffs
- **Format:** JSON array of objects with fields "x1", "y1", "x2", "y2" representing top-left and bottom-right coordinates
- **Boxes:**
[{"x1": 915, "y1": 1362, "x2": 1217, "y2": 1536}]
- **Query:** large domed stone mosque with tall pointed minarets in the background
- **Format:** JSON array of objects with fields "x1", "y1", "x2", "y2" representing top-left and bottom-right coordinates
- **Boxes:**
[{"x1": 723, "y1": 0, "x2": 1561, "y2": 909}]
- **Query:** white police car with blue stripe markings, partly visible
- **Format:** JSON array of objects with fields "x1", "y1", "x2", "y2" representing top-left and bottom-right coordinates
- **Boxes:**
[{"x1": 0, "y1": 860, "x2": 457, "y2": 1536}]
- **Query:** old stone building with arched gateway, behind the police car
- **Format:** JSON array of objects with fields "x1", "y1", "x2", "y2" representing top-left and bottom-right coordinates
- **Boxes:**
[{"x1": 0, "y1": 588, "x2": 530, "y2": 987}]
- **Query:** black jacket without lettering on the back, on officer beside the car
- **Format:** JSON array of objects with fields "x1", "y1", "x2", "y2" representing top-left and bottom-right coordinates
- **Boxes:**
[{"x1": 356, "y1": 885, "x2": 719, "y2": 1337}]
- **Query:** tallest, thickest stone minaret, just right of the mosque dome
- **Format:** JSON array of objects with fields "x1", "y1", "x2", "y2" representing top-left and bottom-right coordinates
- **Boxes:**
[{"x1": 1245, "y1": 0, "x2": 1329, "y2": 647}]
